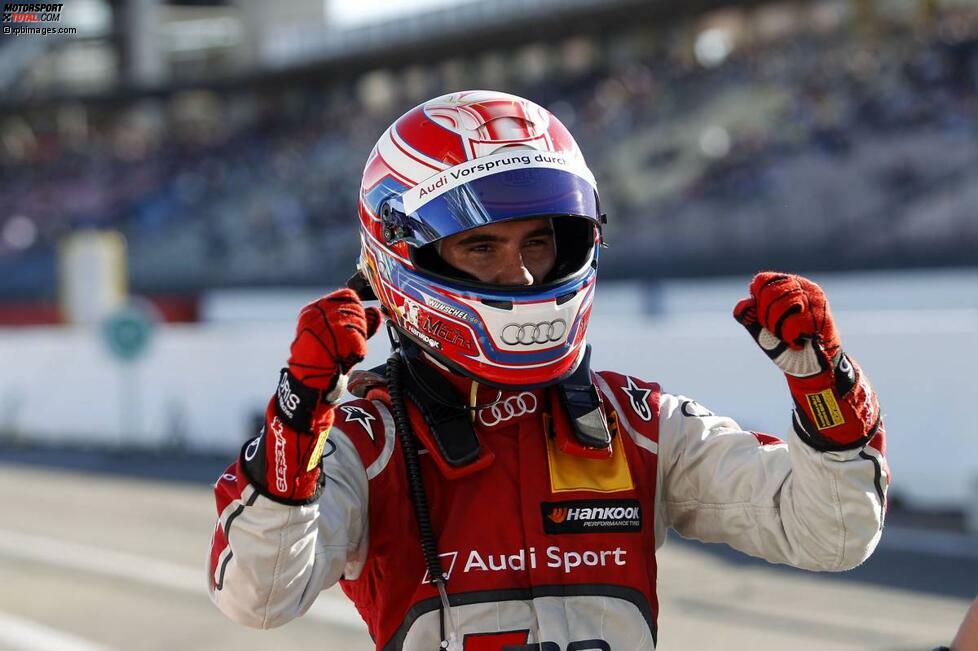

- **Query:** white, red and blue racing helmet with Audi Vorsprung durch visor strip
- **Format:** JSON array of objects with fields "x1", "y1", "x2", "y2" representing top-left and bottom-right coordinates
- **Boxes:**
[{"x1": 360, "y1": 91, "x2": 603, "y2": 388}]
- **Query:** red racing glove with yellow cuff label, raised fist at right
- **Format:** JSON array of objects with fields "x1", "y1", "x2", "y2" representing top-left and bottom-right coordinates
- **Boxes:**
[{"x1": 734, "y1": 271, "x2": 882, "y2": 451}]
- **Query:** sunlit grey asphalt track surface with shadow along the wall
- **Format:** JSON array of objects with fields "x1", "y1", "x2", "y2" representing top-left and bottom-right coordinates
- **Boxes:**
[{"x1": 0, "y1": 449, "x2": 978, "y2": 651}]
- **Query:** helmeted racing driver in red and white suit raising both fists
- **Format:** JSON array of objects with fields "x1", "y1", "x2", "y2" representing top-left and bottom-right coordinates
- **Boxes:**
[{"x1": 209, "y1": 91, "x2": 889, "y2": 651}]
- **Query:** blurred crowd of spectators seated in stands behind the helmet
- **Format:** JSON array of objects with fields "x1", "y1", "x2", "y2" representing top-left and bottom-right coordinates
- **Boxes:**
[{"x1": 0, "y1": 4, "x2": 978, "y2": 296}]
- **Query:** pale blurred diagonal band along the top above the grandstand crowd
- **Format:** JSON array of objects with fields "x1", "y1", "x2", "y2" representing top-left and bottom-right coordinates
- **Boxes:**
[{"x1": 0, "y1": 0, "x2": 771, "y2": 110}]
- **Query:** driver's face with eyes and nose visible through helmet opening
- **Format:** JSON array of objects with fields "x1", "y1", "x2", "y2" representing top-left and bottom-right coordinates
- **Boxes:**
[{"x1": 440, "y1": 217, "x2": 557, "y2": 285}]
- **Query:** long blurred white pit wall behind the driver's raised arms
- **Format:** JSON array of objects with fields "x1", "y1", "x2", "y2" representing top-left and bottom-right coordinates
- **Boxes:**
[{"x1": 0, "y1": 271, "x2": 978, "y2": 507}]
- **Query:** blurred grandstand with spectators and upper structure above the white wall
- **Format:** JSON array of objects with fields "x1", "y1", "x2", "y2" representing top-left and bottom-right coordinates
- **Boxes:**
[{"x1": 0, "y1": 0, "x2": 978, "y2": 305}]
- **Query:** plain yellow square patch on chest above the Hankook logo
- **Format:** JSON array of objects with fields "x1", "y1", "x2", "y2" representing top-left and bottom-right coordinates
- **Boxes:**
[{"x1": 547, "y1": 416, "x2": 635, "y2": 493}]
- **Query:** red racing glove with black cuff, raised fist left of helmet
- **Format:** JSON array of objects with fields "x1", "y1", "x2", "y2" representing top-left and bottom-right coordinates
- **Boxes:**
[{"x1": 238, "y1": 289, "x2": 381, "y2": 505}]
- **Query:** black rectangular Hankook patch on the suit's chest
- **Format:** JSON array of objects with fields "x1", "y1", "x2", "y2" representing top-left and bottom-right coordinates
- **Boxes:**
[{"x1": 540, "y1": 500, "x2": 642, "y2": 533}]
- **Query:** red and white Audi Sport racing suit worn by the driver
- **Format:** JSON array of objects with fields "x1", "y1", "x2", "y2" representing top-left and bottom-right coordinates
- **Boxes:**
[{"x1": 210, "y1": 372, "x2": 888, "y2": 651}]
